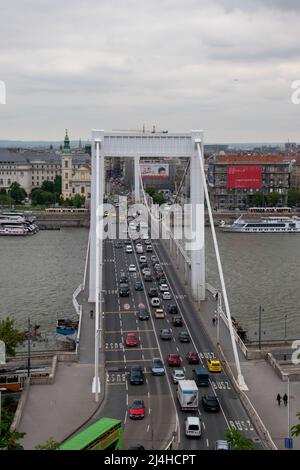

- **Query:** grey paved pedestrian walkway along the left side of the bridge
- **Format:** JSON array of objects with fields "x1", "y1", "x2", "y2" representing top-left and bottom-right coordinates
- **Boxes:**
[{"x1": 18, "y1": 278, "x2": 103, "y2": 450}]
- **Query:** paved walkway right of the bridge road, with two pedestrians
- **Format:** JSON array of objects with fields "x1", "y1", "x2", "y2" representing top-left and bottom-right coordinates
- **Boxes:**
[{"x1": 199, "y1": 293, "x2": 300, "y2": 449}]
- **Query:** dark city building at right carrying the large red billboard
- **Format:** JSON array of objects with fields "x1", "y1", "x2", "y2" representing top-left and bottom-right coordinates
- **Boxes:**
[{"x1": 208, "y1": 155, "x2": 291, "y2": 209}]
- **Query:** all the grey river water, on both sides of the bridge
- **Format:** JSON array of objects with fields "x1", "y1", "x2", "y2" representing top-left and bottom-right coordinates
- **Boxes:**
[{"x1": 0, "y1": 228, "x2": 300, "y2": 349}]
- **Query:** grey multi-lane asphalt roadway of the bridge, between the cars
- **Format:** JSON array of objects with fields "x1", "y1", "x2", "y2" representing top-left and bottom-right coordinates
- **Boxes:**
[{"x1": 102, "y1": 207, "x2": 258, "y2": 450}]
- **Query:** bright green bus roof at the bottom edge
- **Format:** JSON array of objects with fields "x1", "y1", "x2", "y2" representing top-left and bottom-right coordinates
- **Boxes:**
[{"x1": 59, "y1": 418, "x2": 123, "y2": 450}]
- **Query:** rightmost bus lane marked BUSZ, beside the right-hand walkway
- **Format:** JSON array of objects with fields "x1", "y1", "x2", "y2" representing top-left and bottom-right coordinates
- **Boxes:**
[{"x1": 154, "y1": 241, "x2": 258, "y2": 439}]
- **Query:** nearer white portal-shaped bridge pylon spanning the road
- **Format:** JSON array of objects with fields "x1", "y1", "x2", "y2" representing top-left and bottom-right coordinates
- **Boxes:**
[{"x1": 89, "y1": 129, "x2": 205, "y2": 304}]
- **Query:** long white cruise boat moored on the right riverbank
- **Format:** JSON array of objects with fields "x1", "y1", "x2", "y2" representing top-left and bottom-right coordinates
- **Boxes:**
[{"x1": 220, "y1": 215, "x2": 300, "y2": 233}]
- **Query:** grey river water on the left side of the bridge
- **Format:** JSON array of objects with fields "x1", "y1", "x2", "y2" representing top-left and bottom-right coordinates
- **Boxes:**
[{"x1": 0, "y1": 228, "x2": 88, "y2": 350}]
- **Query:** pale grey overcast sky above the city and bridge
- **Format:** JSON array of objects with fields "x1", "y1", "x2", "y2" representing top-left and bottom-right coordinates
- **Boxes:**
[{"x1": 0, "y1": 0, "x2": 300, "y2": 142}]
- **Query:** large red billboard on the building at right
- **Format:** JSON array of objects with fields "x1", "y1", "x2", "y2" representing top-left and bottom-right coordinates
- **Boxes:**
[{"x1": 227, "y1": 165, "x2": 261, "y2": 189}]
